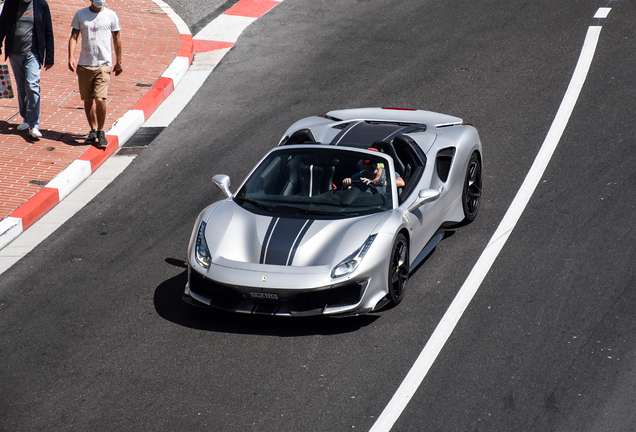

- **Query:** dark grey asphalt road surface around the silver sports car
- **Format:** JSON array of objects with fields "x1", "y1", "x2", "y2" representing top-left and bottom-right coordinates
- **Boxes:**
[{"x1": 0, "y1": 0, "x2": 636, "y2": 431}]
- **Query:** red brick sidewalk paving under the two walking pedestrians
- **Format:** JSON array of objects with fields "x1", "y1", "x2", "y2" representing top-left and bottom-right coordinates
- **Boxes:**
[{"x1": 0, "y1": 0, "x2": 181, "y2": 220}]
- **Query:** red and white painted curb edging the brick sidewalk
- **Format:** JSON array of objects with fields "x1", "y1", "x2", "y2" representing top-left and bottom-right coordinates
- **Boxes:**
[{"x1": 0, "y1": 0, "x2": 283, "y2": 249}]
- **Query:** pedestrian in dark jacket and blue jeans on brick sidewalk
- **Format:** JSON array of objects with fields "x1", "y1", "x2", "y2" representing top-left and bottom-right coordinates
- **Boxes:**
[{"x1": 0, "y1": 0, "x2": 55, "y2": 139}]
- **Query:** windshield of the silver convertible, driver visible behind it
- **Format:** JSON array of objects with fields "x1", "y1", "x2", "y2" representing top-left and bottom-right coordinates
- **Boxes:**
[{"x1": 235, "y1": 146, "x2": 393, "y2": 217}]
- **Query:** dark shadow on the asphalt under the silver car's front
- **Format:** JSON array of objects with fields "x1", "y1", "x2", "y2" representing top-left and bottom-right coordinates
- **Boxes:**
[{"x1": 154, "y1": 258, "x2": 380, "y2": 337}]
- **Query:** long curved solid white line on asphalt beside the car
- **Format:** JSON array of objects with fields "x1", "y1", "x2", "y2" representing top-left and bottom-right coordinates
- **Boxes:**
[{"x1": 370, "y1": 26, "x2": 601, "y2": 432}]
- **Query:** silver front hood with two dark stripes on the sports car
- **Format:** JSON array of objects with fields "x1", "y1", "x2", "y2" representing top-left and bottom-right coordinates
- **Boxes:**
[{"x1": 203, "y1": 200, "x2": 387, "y2": 267}]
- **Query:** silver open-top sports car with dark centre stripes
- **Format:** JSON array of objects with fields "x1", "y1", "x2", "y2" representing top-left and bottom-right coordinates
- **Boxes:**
[{"x1": 183, "y1": 108, "x2": 482, "y2": 316}]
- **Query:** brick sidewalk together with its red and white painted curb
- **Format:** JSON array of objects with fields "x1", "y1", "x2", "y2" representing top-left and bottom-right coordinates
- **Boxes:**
[{"x1": 0, "y1": 0, "x2": 283, "y2": 253}]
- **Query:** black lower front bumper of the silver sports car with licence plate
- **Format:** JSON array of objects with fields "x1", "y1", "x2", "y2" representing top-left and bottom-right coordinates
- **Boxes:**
[{"x1": 183, "y1": 267, "x2": 373, "y2": 316}]
